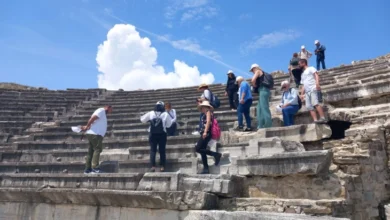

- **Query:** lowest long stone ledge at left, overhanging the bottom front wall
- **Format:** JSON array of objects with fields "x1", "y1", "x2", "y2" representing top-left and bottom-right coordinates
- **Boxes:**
[{"x1": 0, "y1": 187, "x2": 218, "y2": 210}]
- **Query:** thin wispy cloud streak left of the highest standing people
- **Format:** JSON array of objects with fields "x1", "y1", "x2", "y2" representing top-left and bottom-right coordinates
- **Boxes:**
[{"x1": 241, "y1": 29, "x2": 301, "y2": 53}]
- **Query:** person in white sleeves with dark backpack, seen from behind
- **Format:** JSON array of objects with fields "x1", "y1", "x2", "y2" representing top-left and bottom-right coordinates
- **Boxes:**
[{"x1": 141, "y1": 101, "x2": 172, "y2": 172}]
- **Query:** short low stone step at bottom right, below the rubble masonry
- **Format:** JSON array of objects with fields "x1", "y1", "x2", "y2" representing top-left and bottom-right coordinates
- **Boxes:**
[{"x1": 220, "y1": 198, "x2": 351, "y2": 219}]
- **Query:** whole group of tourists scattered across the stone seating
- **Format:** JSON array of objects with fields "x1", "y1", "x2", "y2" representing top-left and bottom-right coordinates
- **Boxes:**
[{"x1": 81, "y1": 40, "x2": 327, "y2": 174}]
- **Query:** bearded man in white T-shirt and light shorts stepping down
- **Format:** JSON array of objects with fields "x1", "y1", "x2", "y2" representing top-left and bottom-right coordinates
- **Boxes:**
[{"x1": 299, "y1": 59, "x2": 327, "y2": 123}]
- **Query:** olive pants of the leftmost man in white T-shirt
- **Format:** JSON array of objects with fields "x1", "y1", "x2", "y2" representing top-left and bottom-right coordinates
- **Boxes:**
[{"x1": 85, "y1": 134, "x2": 103, "y2": 169}]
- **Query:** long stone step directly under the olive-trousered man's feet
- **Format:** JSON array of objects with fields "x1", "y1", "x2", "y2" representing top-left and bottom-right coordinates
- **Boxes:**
[{"x1": 0, "y1": 172, "x2": 245, "y2": 197}]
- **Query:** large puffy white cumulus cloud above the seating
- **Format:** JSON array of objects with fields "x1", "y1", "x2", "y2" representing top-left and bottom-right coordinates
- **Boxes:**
[{"x1": 96, "y1": 24, "x2": 215, "y2": 90}]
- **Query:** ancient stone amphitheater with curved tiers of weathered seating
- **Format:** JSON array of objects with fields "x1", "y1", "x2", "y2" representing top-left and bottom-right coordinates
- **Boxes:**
[{"x1": 0, "y1": 55, "x2": 390, "y2": 220}]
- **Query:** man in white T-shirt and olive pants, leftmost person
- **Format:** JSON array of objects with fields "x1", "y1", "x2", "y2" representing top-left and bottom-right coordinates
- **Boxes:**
[{"x1": 81, "y1": 105, "x2": 112, "y2": 174}]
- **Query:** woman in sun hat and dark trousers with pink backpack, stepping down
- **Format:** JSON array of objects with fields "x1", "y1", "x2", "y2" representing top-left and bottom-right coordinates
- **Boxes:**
[{"x1": 195, "y1": 101, "x2": 222, "y2": 174}]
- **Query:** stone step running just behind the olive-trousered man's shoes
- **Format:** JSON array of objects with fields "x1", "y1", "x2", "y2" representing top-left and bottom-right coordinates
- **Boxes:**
[{"x1": 0, "y1": 158, "x2": 198, "y2": 174}]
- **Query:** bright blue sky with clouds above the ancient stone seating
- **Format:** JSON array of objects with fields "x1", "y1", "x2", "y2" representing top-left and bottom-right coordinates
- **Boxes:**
[{"x1": 0, "y1": 0, "x2": 390, "y2": 90}]
